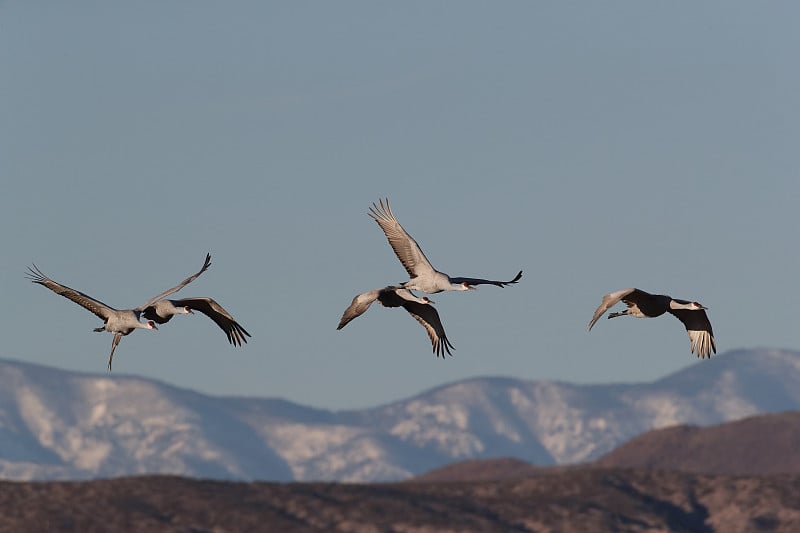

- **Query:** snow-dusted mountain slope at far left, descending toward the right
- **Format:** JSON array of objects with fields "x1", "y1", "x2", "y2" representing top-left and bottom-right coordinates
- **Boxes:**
[{"x1": 0, "y1": 363, "x2": 291, "y2": 480}]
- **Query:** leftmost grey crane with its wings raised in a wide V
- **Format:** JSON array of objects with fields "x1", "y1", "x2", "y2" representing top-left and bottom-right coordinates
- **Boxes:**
[{"x1": 27, "y1": 254, "x2": 211, "y2": 372}]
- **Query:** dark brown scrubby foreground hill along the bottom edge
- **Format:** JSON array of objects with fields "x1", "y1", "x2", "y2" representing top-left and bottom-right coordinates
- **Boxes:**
[{"x1": 0, "y1": 467, "x2": 800, "y2": 533}]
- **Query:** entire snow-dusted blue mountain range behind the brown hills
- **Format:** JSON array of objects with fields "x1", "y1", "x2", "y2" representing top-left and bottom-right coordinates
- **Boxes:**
[{"x1": 0, "y1": 350, "x2": 800, "y2": 481}]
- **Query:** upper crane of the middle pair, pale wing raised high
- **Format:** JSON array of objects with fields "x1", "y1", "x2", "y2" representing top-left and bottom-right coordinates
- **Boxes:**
[{"x1": 369, "y1": 198, "x2": 522, "y2": 294}]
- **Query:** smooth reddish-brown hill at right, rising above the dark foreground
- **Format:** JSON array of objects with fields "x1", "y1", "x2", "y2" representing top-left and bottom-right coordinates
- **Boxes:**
[{"x1": 594, "y1": 412, "x2": 800, "y2": 475}]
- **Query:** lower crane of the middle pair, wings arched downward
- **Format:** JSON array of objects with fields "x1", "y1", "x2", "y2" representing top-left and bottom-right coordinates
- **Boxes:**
[{"x1": 336, "y1": 286, "x2": 455, "y2": 357}]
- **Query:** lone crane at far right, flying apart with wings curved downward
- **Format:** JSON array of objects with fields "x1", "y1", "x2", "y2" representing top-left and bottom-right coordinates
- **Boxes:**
[{"x1": 589, "y1": 288, "x2": 717, "y2": 358}]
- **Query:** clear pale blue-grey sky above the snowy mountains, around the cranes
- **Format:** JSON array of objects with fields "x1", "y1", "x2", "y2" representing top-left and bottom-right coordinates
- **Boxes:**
[{"x1": 0, "y1": 0, "x2": 800, "y2": 408}]
